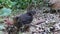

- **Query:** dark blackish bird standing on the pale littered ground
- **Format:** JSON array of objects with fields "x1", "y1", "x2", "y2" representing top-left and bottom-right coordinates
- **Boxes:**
[{"x1": 14, "y1": 11, "x2": 36, "y2": 32}]
